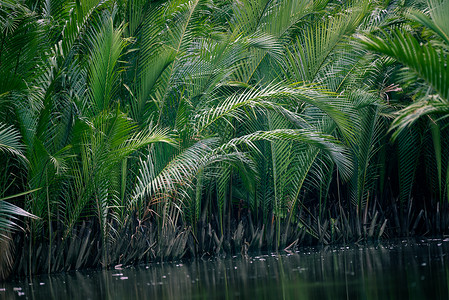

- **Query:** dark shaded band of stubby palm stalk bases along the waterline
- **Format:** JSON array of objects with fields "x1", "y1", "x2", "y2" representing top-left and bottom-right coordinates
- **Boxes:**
[{"x1": 7, "y1": 197, "x2": 449, "y2": 276}]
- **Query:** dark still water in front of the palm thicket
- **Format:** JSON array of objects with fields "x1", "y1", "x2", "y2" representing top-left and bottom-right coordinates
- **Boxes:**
[{"x1": 0, "y1": 239, "x2": 449, "y2": 300}]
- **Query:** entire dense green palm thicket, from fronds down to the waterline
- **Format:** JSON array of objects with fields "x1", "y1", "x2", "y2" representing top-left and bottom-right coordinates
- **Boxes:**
[{"x1": 0, "y1": 0, "x2": 449, "y2": 276}]
